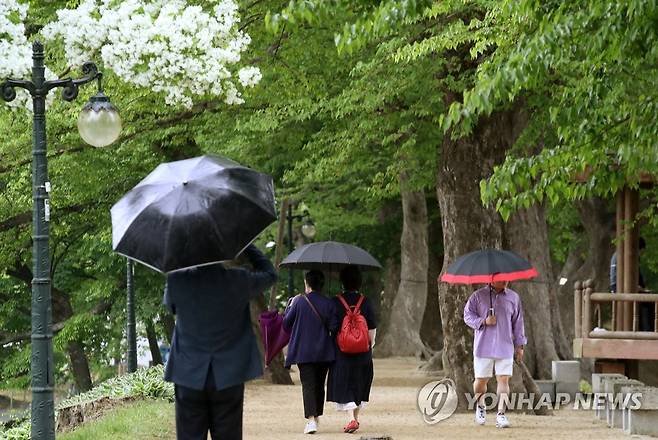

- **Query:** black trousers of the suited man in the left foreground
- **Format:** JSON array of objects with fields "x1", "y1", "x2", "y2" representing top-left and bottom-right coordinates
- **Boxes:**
[{"x1": 174, "y1": 370, "x2": 244, "y2": 440}]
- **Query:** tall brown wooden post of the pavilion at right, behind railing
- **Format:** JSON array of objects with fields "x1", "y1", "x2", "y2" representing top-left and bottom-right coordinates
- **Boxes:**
[{"x1": 623, "y1": 187, "x2": 639, "y2": 331}]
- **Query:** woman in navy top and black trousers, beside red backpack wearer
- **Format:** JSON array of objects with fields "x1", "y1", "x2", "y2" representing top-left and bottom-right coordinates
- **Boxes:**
[{"x1": 283, "y1": 270, "x2": 338, "y2": 434}]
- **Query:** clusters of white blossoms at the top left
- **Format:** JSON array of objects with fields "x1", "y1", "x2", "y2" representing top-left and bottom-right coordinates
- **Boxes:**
[{"x1": 0, "y1": 0, "x2": 262, "y2": 108}]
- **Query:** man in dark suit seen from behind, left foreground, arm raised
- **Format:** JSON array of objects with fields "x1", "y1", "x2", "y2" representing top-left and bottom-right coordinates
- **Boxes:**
[{"x1": 164, "y1": 245, "x2": 277, "y2": 440}]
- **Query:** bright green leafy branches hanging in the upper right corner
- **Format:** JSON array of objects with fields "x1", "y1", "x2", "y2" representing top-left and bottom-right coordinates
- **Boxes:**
[{"x1": 442, "y1": 0, "x2": 658, "y2": 220}]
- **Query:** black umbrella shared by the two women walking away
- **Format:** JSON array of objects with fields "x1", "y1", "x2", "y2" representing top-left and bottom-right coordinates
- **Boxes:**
[{"x1": 279, "y1": 241, "x2": 382, "y2": 272}]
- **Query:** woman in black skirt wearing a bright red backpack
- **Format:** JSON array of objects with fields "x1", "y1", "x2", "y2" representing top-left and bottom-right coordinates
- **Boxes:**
[{"x1": 327, "y1": 266, "x2": 377, "y2": 434}]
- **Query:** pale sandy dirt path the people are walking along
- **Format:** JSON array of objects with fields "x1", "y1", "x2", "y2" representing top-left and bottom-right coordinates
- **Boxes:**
[{"x1": 244, "y1": 358, "x2": 639, "y2": 440}]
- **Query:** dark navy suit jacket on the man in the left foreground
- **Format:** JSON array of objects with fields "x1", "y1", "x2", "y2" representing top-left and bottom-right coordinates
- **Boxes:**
[{"x1": 164, "y1": 245, "x2": 277, "y2": 390}]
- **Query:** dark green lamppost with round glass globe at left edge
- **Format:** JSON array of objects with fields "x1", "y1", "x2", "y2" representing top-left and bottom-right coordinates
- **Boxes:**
[{"x1": 0, "y1": 41, "x2": 121, "y2": 440}]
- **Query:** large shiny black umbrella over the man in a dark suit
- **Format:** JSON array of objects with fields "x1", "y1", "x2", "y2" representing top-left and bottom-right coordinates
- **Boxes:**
[{"x1": 112, "y1": 156, "x2": 276, "y2": 273}]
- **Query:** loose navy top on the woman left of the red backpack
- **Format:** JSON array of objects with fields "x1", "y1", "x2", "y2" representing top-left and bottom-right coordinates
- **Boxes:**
[{"x1": 283, "y1": 292, "x2": 338, "y2": 367}]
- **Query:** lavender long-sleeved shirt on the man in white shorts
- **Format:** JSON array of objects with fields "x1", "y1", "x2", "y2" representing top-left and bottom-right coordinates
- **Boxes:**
[{"x1": 464, "y1": 285, "x2": 528, "y2": 359}]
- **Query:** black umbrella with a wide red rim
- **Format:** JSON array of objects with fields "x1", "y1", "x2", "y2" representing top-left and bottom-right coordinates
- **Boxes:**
[{"x1": 441, "y1": 249, "x2": 537, "y2": 284}]
